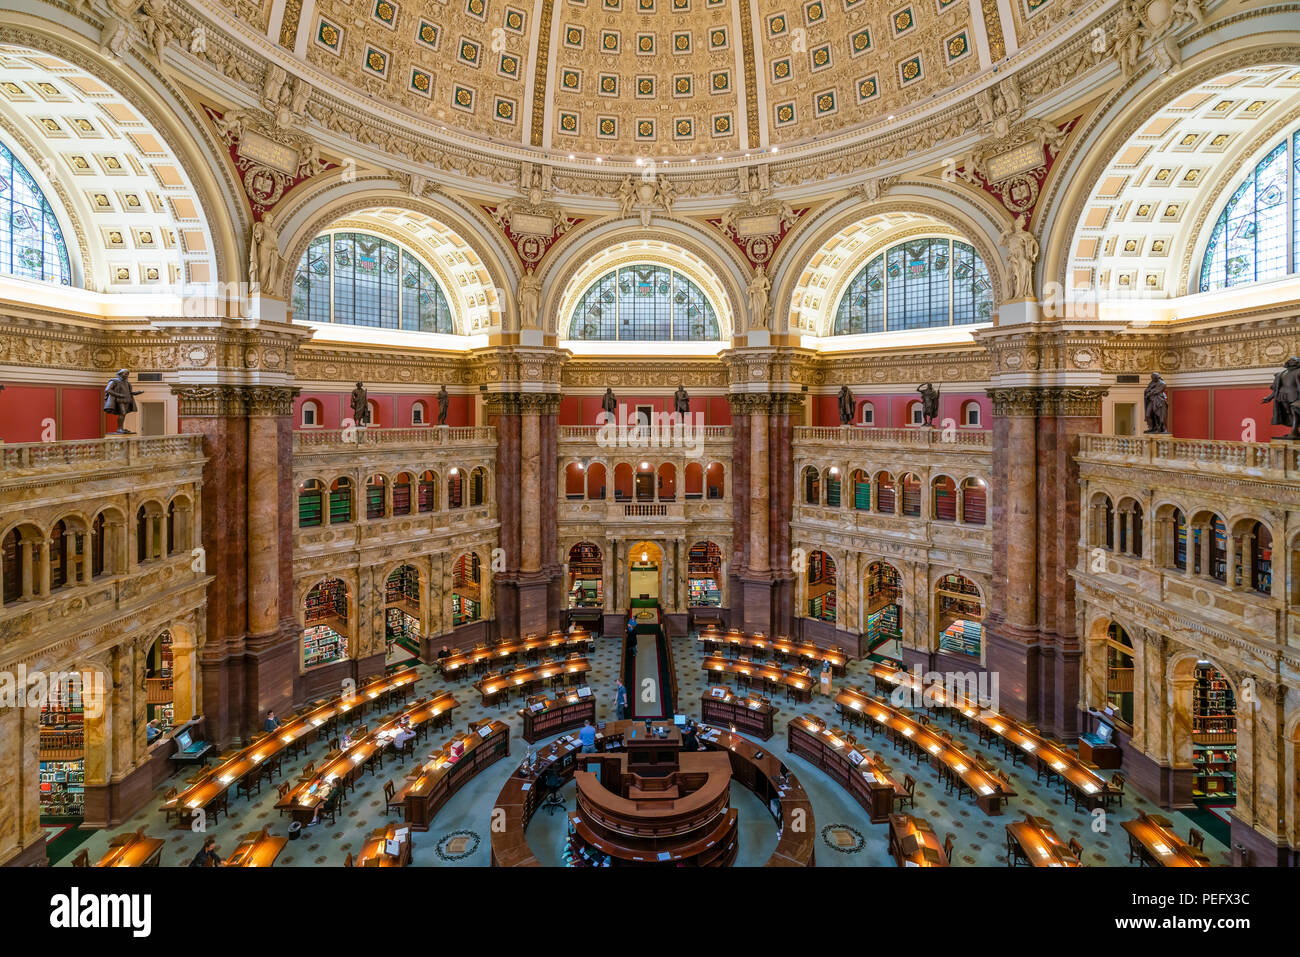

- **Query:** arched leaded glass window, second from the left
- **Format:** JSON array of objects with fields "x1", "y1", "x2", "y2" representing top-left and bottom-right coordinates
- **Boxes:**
[{"x1": 294, "y1": 233, "x2": 455, "y2": 333}]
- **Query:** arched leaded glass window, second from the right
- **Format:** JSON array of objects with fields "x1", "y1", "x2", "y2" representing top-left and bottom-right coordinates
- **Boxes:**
[{"x1": 833, "y1": 238, "x2": 993, "y2": 335}]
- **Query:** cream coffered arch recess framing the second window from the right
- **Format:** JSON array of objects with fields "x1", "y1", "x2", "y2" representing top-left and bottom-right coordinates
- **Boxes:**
[{"x1": 772, "y1": 183, "x2": 1010, "y2": 351}]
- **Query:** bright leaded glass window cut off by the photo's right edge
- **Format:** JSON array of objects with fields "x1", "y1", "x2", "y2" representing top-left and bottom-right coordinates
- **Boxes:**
[{"x1": 1200, "y1": 130, "x2": 1300, "y2": 293}]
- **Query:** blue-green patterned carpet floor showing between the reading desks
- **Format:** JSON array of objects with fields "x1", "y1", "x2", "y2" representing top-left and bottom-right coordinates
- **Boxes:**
[{"x1": 50, "y1": 635, "x2": 1229, "y2": 866}]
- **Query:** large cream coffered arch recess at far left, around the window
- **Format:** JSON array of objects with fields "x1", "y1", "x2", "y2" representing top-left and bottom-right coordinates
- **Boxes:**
[{"x1": 0, "y1": 22, "x2": 243, "y2": 304}]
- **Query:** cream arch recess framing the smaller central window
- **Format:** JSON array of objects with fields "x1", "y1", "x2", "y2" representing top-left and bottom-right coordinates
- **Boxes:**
[{"x1": 541, "y1": 218, "x2": 749, "y2": 355}]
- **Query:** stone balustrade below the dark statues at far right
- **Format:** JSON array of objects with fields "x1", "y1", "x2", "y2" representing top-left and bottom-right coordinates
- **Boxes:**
[{"x1": 1079, "y1": 434, "x2": 1300, "y2": 479}]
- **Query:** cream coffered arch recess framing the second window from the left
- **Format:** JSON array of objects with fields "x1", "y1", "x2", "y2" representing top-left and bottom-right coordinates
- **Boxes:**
[{"x1": 277, "y1": 174, "x2": 517, "y2": 350}]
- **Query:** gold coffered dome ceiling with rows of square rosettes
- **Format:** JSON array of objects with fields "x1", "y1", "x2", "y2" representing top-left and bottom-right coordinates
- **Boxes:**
[{"x1": 235, "y1": 0, "x2": 1070, "y2": 159}]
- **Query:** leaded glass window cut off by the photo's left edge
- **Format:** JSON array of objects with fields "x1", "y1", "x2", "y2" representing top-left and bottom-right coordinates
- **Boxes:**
[{"x1": 0, "y1": 137, "x2": 73, "y2": 286}]
